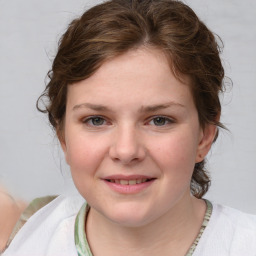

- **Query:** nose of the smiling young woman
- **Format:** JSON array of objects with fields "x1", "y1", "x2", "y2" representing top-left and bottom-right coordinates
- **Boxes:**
[{"x1": 109, "y1": 126, "x2": 146, "y2": 165}]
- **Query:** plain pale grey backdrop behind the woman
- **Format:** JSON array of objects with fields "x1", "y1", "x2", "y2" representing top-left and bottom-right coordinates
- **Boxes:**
[{"x1": 0, "y1": 0, "x2": 256, "y2": 214}]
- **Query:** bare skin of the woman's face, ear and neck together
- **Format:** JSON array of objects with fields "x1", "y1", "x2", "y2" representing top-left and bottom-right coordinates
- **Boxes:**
[{"x1": 60, "y1": 48, "x2": 216, "y2": 256}]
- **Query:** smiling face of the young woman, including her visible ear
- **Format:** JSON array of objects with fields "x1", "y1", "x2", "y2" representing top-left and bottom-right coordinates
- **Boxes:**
[{"x1": 61, "y1": 48, "x2": 214, "y2": 226}]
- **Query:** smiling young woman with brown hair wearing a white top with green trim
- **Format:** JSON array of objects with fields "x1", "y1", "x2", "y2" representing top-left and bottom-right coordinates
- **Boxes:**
[{"x1": 3, "y1": 0, "x2": 256, "y2": 256}]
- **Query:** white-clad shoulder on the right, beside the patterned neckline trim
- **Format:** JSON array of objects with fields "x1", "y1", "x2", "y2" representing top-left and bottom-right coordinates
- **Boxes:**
[{"x1": 195, "y1": 203, "x2": 256, "y2": 256}]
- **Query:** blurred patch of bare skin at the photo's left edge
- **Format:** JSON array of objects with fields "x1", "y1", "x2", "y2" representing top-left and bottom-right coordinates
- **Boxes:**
[{"x1": 0, "y1": 188, "x2": 27, "y2": 251}]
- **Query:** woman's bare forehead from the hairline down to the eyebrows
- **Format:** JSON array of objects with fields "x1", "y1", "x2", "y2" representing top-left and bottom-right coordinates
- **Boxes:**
[{"x1": 67, "y1": 48, "x2": 192, "y2": 111}]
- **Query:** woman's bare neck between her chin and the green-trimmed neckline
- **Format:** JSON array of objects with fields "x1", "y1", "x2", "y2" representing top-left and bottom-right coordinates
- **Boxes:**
[{"x1": 86, "y1": 196, "x2": 206, "y2": 256}]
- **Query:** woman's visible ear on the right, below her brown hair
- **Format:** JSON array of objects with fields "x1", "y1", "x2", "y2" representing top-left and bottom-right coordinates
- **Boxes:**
[{"x1": 196, "y1": 124, "x2": 218, "y2": 163}]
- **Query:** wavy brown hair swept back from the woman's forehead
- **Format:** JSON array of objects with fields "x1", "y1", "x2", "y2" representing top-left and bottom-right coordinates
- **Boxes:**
[{"x1": 37, "y1": 0, "x2": 224, "y2": 198}]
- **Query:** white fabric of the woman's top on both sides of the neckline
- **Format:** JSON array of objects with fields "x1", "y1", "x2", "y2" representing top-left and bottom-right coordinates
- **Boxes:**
[{"x1": 2, "y1": 195, "x2": 256, "y2": 256}]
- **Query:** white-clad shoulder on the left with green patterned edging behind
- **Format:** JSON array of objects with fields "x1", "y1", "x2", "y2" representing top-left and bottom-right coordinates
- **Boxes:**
[{"x1": 3, "y1": 194, "x2": 84, "y2": 256}]
